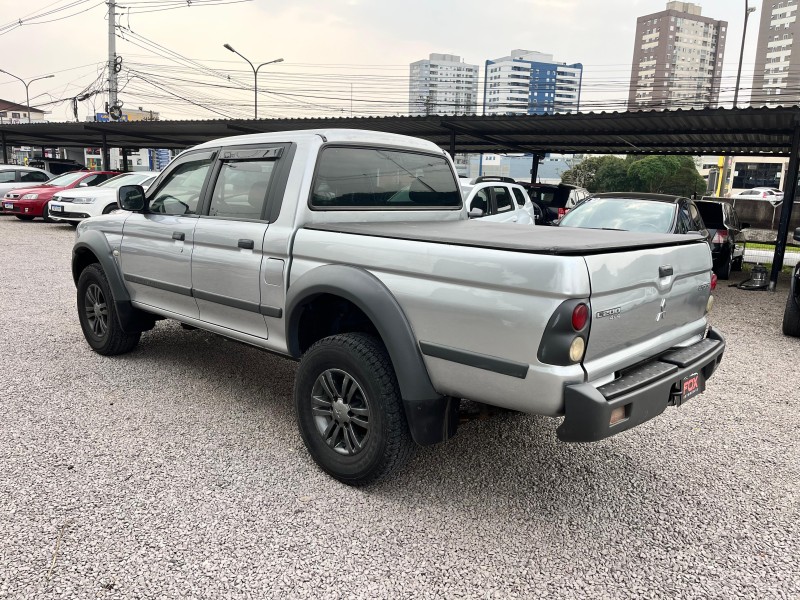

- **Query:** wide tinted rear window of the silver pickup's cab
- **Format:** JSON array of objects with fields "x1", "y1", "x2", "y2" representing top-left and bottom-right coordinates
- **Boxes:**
[{"x1": 310, "y1": 146, "x2": 462, "y2": 210}]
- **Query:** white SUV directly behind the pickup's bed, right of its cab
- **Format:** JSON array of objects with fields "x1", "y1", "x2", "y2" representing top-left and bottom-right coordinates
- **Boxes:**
[{"x1": 461, "y1": 177, "x2": 540, "y2": 225}]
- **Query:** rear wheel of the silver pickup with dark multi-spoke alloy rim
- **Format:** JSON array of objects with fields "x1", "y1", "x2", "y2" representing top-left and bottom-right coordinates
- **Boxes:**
[{"x1": 294, "y1": 333, "x2": 414, "y2": 486}]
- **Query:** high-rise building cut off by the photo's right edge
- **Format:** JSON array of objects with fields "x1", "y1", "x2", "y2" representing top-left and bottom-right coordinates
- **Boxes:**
[{"x1": 750, "y1": 0, "x2": 800, "y2": 106}]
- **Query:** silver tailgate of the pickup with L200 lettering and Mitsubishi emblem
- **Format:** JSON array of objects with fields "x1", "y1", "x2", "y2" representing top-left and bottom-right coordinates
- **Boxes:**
[{"x1": 585, "y1": 241, "x2": 711, "y2": 370}]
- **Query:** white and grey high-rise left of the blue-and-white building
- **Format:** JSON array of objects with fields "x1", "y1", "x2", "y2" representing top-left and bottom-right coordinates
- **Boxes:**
[{"x1": 408, "y1": 54, "x2": 478, "y2": 116}]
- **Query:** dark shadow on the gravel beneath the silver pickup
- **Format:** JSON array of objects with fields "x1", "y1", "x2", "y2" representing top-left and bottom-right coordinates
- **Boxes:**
[{"x1": 125, "y1": 323, "x2": 683, "y2": 522}]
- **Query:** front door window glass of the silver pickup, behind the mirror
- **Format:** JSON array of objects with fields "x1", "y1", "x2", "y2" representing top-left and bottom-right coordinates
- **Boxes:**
[{"x1": 150, "y1": 152, "x2": 214, "y2": 215}]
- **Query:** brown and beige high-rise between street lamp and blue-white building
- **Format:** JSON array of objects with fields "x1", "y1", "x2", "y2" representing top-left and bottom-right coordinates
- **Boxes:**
[{"x1": 628, "y1": 2, "x2": 728, "y2": 110}]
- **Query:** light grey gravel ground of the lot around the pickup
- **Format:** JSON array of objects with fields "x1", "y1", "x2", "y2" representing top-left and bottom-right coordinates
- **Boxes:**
[{"x1": 0, "y1": 217, "x2": 800, "y2": 599}]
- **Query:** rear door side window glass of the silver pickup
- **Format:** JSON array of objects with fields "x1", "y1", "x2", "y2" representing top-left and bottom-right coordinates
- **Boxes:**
[{"x1": 208, "y1": 160, "x2": 276, "y2": 220}]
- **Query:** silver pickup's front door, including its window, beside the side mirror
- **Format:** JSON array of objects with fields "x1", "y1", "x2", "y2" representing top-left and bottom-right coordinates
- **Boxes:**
[{"x1": 120, "y1": 150, "x2": 215, "y2": 318}]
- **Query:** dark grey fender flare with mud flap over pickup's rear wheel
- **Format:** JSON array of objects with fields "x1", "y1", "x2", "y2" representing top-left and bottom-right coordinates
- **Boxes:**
[{"x1": 286, "y1": 265, "x2": 459, "y2": 446}]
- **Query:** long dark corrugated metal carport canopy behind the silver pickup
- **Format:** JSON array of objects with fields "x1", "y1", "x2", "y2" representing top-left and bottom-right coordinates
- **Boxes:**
[{"x1": 0, "y1": 107, "x2": 800, "y2": 156}]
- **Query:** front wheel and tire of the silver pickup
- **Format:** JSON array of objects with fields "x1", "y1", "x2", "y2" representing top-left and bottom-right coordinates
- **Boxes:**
[{"x1": 78, "y1": 263, "x2": 142, "y2": 356}]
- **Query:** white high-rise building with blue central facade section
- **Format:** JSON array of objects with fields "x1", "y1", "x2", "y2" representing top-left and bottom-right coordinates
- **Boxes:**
[{"x1": 483, "y1": 50, "x2": 583, "y2": 115}]
